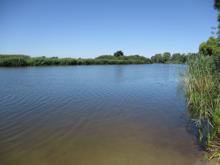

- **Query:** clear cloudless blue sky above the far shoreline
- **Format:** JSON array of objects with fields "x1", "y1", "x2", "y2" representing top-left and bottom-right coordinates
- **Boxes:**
[{"x1": 0, "y1": 0, "x2": 217, "y2": 57}]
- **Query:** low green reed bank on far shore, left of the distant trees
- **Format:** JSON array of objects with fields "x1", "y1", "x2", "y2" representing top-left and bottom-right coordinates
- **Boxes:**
[{"x1": 0, "y1": 55, "x2": 151, "y2": 67}]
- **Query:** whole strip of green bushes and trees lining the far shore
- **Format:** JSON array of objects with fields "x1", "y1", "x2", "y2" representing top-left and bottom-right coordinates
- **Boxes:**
[{"x1": 0, "y1": 51, "x2": 194, "y2": 67}]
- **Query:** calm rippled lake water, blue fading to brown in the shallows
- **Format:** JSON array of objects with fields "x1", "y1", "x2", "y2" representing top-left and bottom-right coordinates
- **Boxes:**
[{"x1": 0, "y1": 65, "x2": 201, "y2": 165}]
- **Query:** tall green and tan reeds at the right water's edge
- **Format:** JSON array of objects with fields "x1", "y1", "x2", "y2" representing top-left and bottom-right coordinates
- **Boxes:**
[{"x1": 184, "y1": 55, "x2": 220, "y2": 158}]
